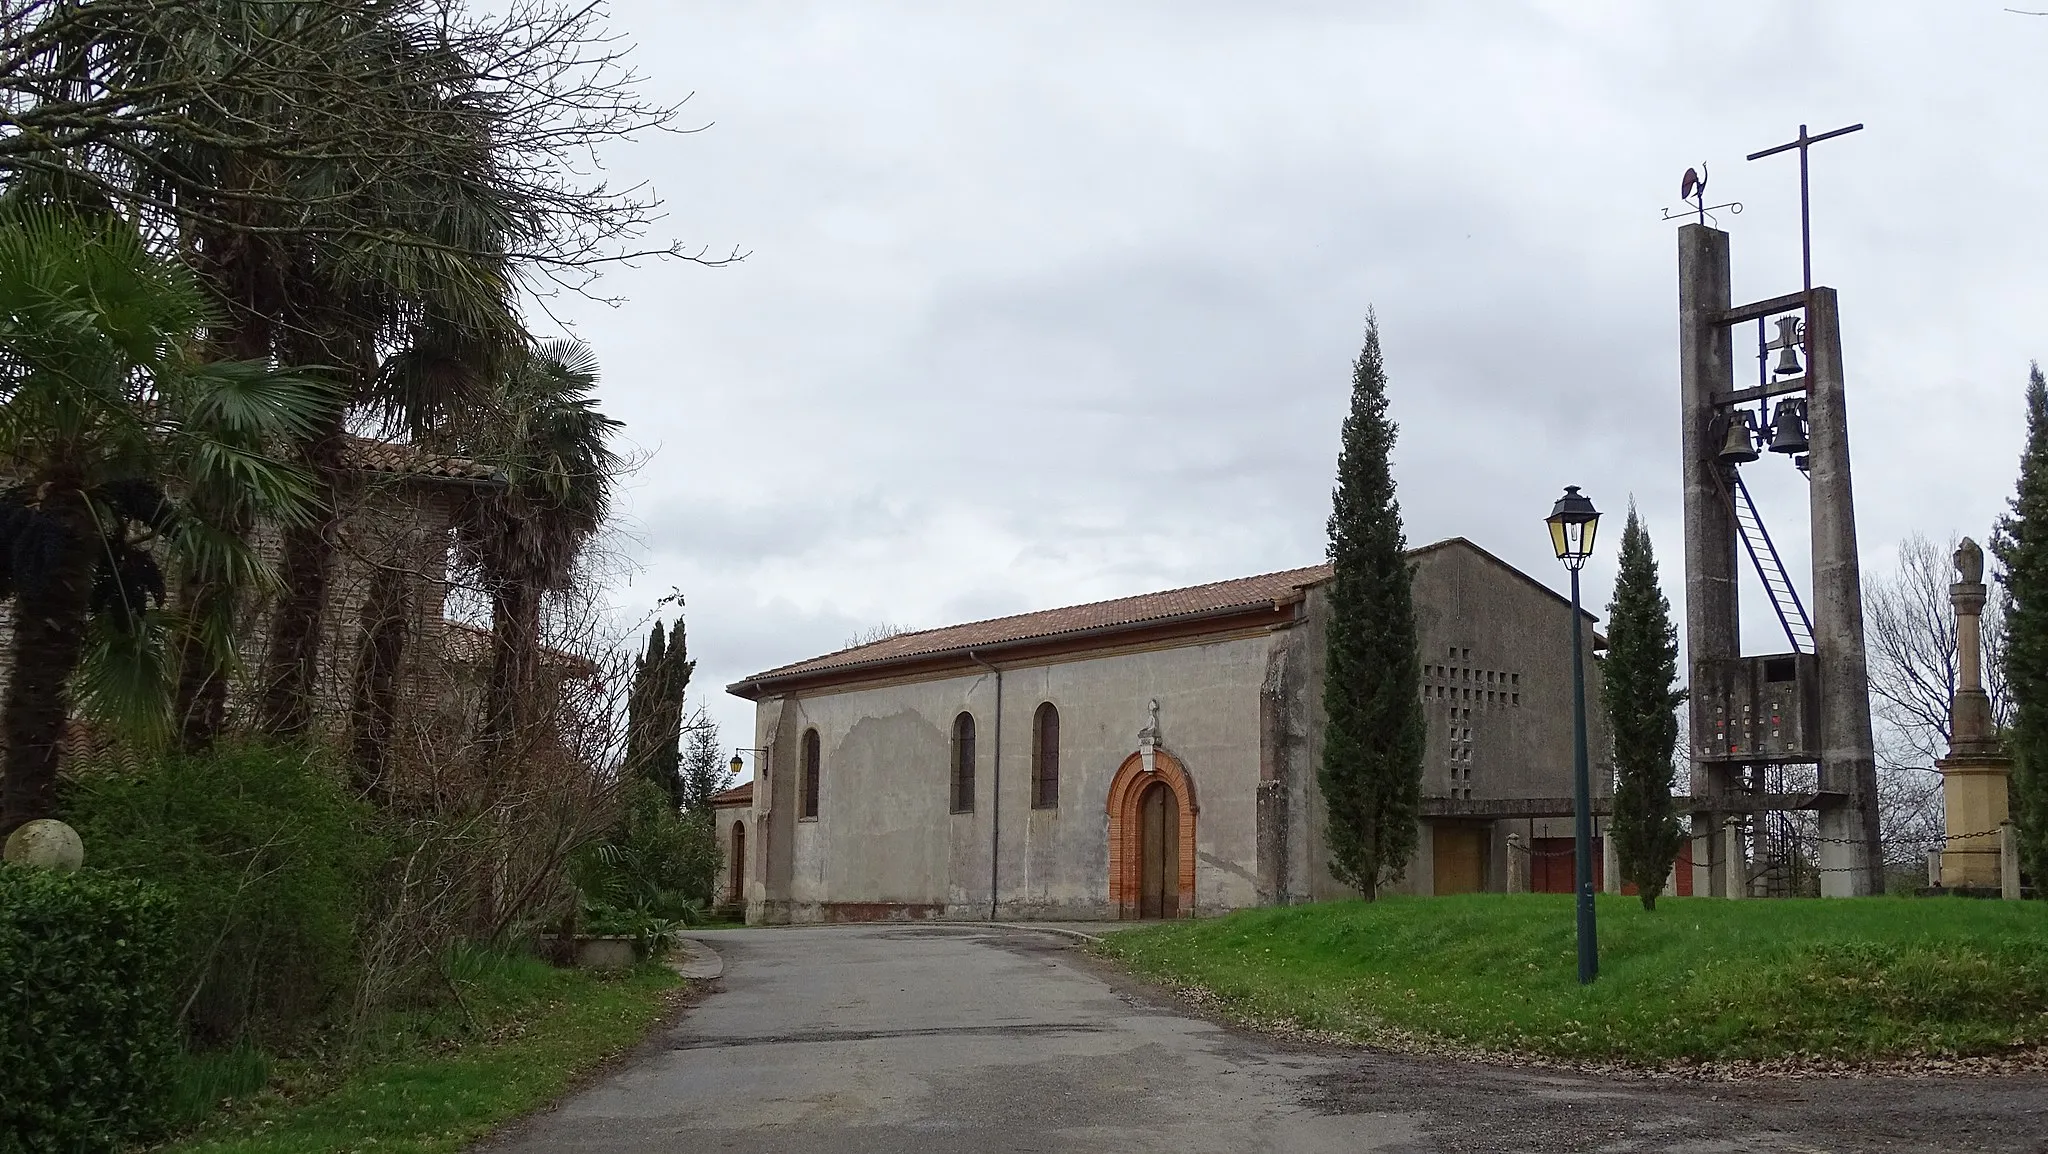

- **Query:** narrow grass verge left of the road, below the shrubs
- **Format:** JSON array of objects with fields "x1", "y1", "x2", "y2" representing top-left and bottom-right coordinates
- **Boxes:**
[{"x1": 166, "y1": 955, "x2": 682, "y2": 1154}]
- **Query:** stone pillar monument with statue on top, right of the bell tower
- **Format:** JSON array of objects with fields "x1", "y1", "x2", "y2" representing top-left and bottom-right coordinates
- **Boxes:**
[{"x1": 1935, "y1": 537, "x2": 2013, "y2": 890}]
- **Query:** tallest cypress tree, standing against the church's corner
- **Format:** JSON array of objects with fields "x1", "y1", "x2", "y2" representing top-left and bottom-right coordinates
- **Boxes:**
[{"x1": 1317, "y1": 312, "x2": 1423, "y2": 900}]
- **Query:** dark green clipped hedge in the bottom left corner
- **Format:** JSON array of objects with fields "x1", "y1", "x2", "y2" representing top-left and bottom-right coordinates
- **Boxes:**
[{"x1": 0, "y1": 865, "x2": 178, "y2": 1154}]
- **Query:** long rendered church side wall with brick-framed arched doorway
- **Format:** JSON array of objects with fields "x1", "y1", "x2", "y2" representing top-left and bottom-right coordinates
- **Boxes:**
[{"x1": 750, "y1": 629, "x2": 1272, "y2": 920}]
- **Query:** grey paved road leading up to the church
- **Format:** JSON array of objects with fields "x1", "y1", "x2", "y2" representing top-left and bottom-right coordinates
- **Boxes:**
[{"x1": 492, "y1": 926, "x2": 2048, "y2": 1154}]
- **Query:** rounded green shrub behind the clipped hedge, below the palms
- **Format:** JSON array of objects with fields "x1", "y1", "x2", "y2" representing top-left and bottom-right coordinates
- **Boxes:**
[{"x1": 70, "y1": 746, "x2": 385, "y2": 1045}]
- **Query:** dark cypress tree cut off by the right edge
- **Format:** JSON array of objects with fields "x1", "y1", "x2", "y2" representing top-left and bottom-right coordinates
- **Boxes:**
[{"x1": 1991, "y1": 365, "x2": 2048, "y2": 894}]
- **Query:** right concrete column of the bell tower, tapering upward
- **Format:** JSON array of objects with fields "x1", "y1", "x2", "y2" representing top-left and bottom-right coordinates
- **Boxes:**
[{"x1": 1806, "y1": 289, "x2": 1884, "y2": 898}]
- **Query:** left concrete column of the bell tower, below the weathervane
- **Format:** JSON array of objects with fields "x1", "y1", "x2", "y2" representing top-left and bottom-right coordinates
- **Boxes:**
[{"x1": 1677, "y1": 223, "x2": 1743, "y2": 894}]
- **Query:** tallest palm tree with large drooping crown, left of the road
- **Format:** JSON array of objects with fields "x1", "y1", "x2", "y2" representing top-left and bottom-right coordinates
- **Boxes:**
[{"x1": 258, "y1": 27, "x2": 524, "y2": 736}]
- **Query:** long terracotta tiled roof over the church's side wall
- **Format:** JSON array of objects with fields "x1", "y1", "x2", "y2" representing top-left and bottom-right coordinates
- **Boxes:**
[{"x1": 748, "y1": 566, "x2": 1329, "y2": 681}]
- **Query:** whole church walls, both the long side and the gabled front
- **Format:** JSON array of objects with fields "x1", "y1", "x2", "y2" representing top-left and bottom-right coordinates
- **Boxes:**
[{"x1": 748, "y1": 539, "x2": 1612, "y2": 922}]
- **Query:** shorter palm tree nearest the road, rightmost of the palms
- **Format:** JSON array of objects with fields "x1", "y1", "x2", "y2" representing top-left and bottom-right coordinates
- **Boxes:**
[{"x1": 457, "y1": 340, "x2": 621, "y2": 740}]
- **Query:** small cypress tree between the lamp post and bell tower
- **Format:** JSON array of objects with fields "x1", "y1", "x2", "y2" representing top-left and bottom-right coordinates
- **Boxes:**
[{"x1": 1602, "y1": 500, "x2": 1686, "y2": 910}]
